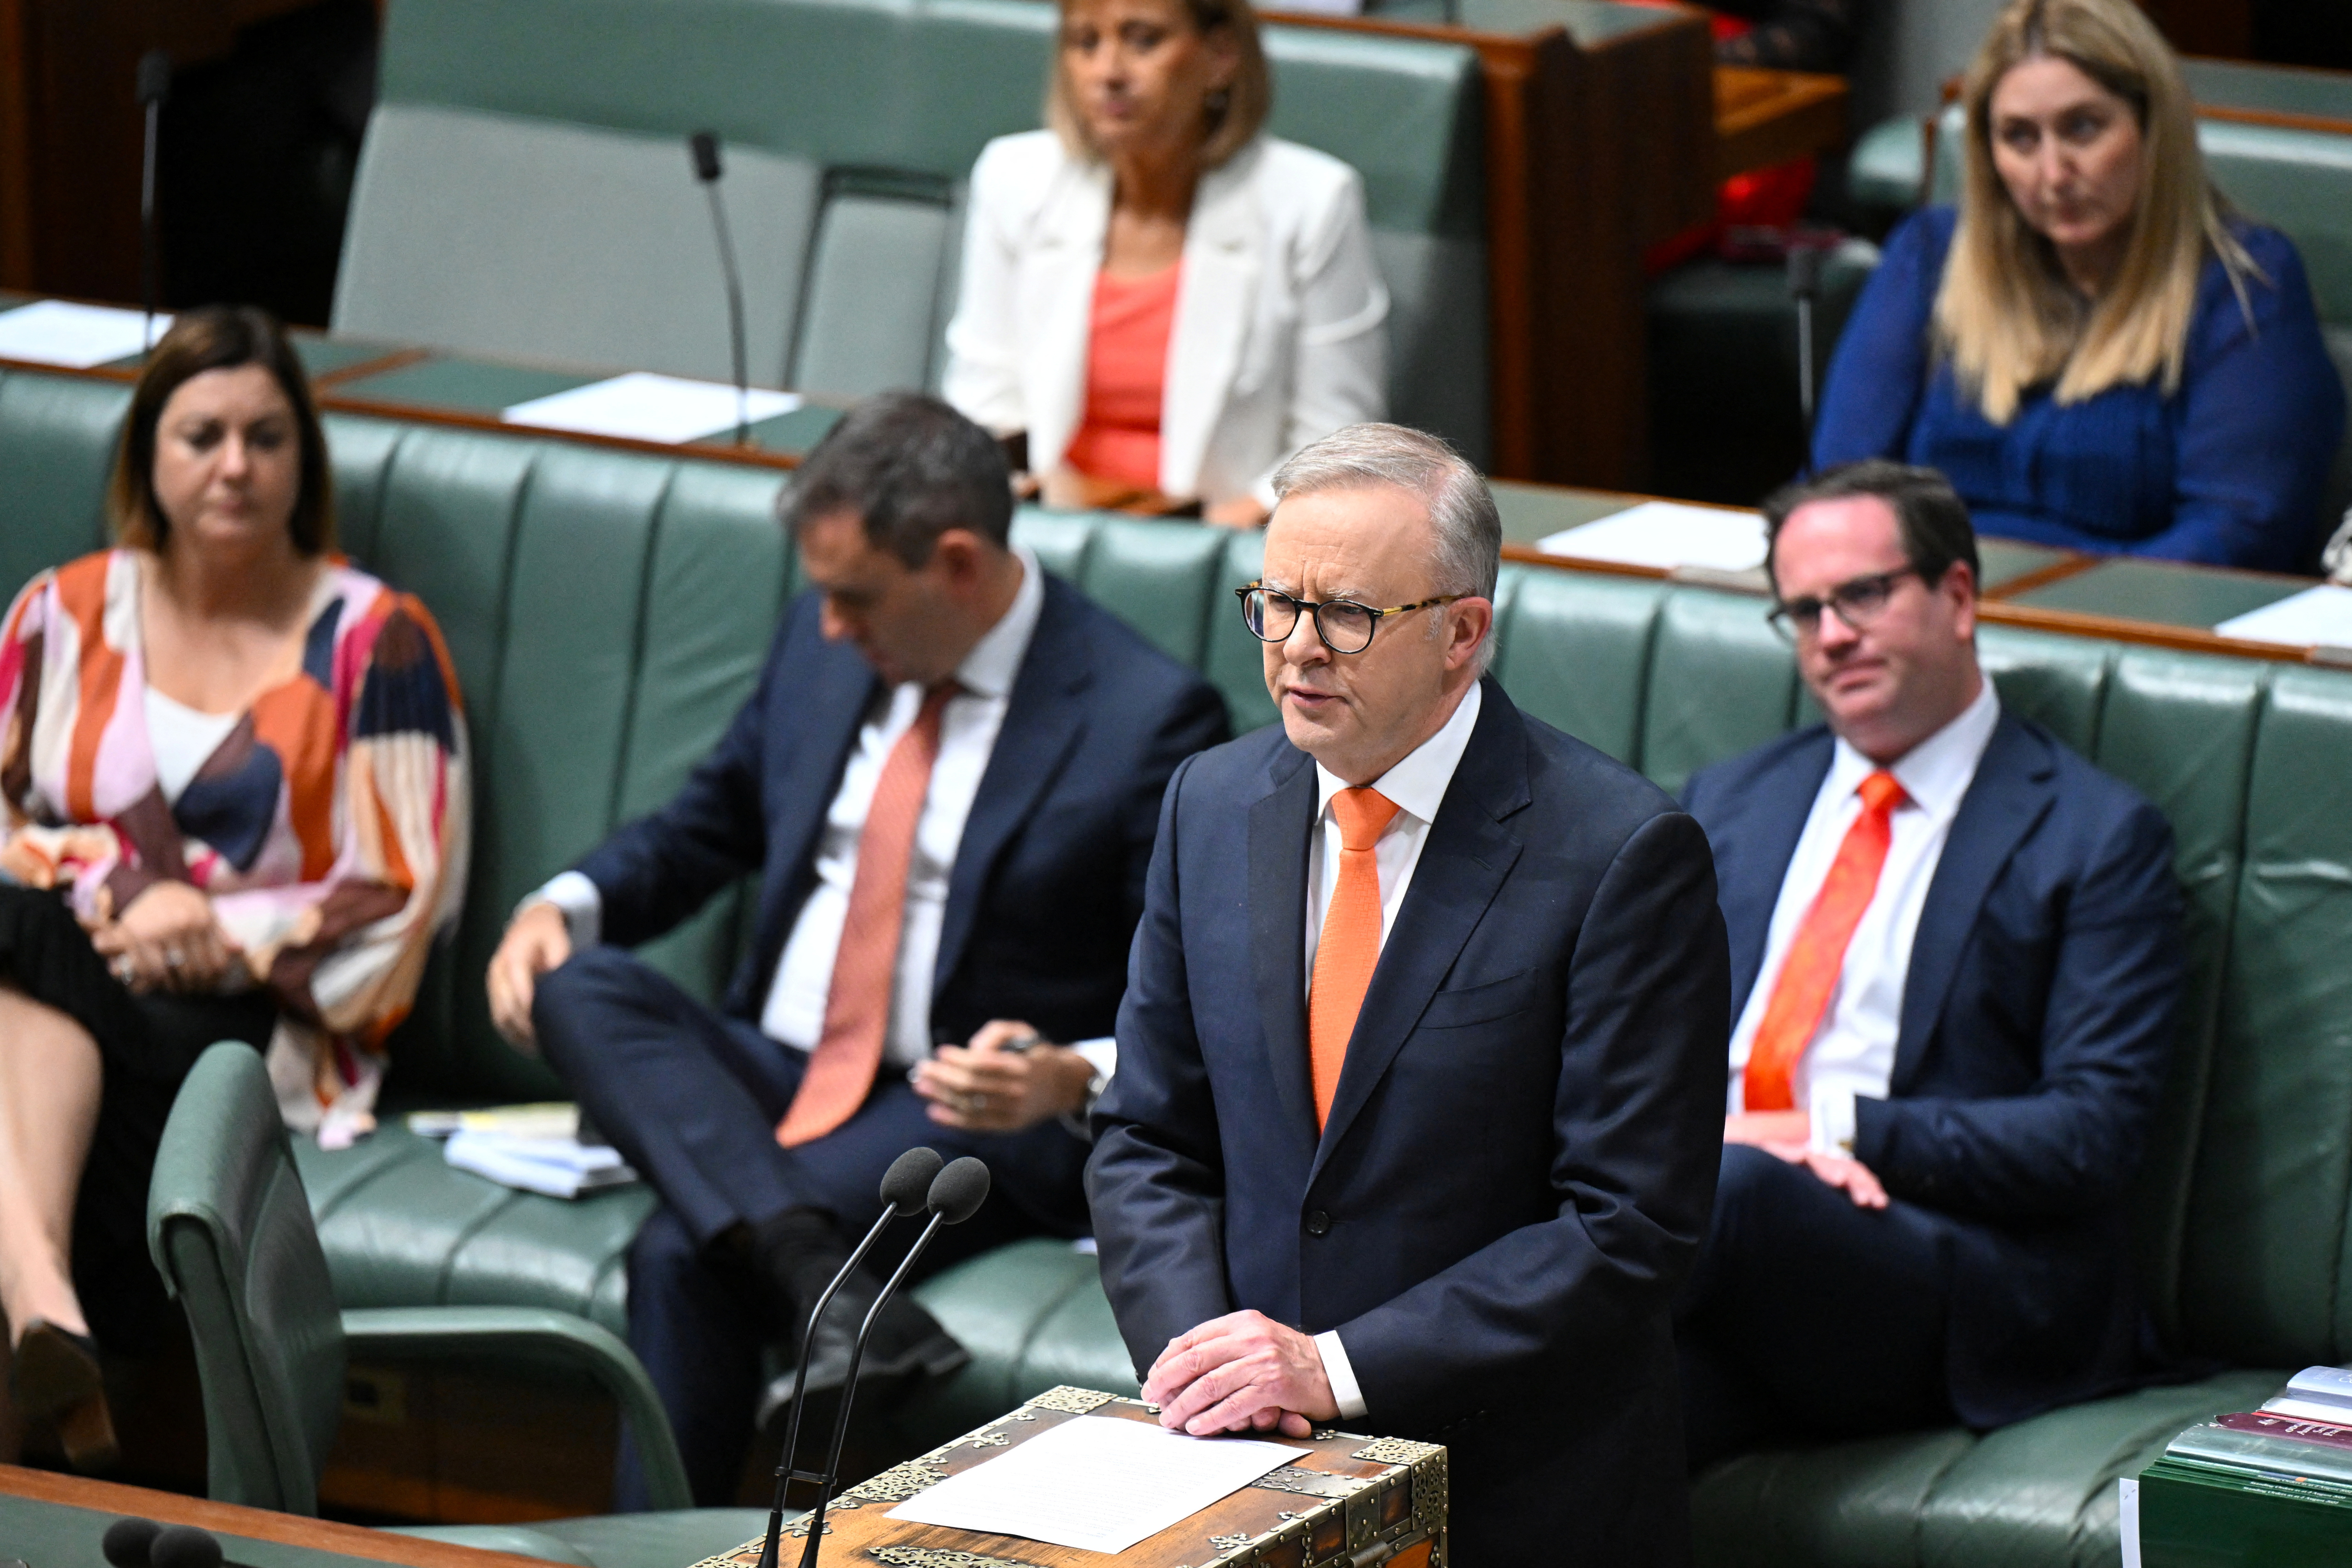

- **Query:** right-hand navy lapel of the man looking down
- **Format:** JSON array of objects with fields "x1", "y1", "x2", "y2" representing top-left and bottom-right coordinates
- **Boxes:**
[{"x1": 931, "y1": 578, "x2": 1094, "y2": 997}]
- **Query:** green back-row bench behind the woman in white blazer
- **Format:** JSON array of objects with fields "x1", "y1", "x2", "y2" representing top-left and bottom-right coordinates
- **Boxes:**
[{"x1": 334, "y1": 0, "x2": 1489, "y2": 465}]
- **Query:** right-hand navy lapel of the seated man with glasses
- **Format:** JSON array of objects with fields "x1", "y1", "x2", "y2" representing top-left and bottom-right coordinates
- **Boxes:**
[{"x1": 1891, "y1": 712, "x2": 2056, "y2": 1093}]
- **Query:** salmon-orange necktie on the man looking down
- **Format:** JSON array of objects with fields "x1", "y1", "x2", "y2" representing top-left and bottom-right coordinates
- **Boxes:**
[{"x1": 776, "y1": 680, "x2": 957, "y2": 1150}]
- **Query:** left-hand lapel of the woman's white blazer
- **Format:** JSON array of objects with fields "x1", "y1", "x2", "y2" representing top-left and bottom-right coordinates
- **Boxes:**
[{"x1": 1021, "y1": 160, "x2": 1110, "y2": 472}]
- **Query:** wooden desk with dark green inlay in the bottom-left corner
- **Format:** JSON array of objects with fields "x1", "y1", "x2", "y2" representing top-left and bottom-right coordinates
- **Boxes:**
[{"x1": 0, "y1": 1464, "x2": 546, "y2": 1568}]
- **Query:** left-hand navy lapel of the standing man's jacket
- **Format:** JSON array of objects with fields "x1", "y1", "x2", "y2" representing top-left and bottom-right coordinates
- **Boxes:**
[{"x1": 1249, "y1": 752, "x2": 1315, "y2": 1145}]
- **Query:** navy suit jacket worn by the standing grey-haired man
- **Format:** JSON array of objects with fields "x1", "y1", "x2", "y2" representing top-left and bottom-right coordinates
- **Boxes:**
[{"x1": 1087, "y1": 680, "x2": 1729, "y2": 1568}]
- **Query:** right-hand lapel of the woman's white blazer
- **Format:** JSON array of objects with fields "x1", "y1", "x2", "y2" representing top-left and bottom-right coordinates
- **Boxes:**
[{"x1": 1160, "y1": 148, "x2": 1263, "y2": 496}]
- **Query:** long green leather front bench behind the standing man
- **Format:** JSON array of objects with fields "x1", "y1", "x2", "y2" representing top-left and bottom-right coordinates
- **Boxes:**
[{"x1": 0, "y1": 372, "x2": 2352, "y2": 1566}]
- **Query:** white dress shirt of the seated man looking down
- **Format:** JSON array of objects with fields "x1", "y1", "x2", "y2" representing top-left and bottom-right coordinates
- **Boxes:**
[{"x1": 524, "y1": 545, "x2": 1115, "y2": 1091}]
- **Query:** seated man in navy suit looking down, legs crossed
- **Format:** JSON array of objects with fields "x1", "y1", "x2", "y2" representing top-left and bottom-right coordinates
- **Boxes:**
[{"x1": 489, "y1": 392, "x2": 1228, "y2": 1507}]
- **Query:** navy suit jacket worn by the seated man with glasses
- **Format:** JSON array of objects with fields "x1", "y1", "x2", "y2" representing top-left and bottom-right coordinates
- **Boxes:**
[{"x1": 1684, "y1": 712, "x2": 2183, "y2": 1427}]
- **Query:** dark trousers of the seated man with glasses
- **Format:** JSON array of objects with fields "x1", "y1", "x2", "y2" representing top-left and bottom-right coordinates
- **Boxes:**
[{"x1": 1675, "y1": 1143, "x2": 1952, "y2": 1474}]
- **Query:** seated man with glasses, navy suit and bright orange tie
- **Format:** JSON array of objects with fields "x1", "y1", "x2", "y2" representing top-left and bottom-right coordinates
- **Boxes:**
[{"x1": 1677, "y1": 461, "x2": 2183, "y2": 1469}]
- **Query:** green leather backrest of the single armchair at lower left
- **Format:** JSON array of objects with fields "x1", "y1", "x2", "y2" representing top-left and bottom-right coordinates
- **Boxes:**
[{"x1": 148, "y1": 1044, "x2": 343, "y2": 1514}]
